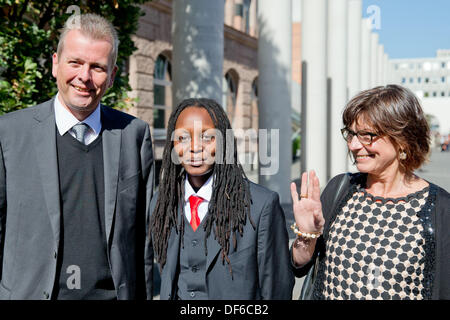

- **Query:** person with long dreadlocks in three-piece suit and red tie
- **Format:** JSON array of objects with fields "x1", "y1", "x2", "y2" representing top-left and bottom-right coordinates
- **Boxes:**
[{"x1": 150, "y1": 99, "x2": 294, "y2": 300}]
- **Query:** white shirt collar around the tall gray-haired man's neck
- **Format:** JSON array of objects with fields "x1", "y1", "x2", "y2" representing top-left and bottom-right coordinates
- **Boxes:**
[{"x1": 55, "y1": 93, "x2": 102, "y2": 145}]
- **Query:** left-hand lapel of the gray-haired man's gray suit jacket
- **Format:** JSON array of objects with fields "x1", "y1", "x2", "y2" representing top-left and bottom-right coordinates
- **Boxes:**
[{"x1": 32, "y1": 98, "x2": 61, "y2": 247}]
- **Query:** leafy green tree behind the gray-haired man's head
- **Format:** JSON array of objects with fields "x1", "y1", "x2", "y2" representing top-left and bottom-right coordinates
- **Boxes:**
[{"x1": 0, "y1": 0, "x2": 147, "y2": 115}]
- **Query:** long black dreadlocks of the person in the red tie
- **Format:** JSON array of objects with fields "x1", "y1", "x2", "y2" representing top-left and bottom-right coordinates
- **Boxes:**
[{"x1": 150, "y1": 98, "x2": 255, "y2": 272}]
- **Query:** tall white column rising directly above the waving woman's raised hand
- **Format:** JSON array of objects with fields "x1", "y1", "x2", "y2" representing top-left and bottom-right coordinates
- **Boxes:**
[{"x1": 301, "y1": 0, "x2": 328, "y2": 186}]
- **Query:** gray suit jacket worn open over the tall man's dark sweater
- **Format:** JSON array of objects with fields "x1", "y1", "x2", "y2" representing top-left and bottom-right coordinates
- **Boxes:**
[{"x1": 0, "y1": 99, "x2": 154, "y2": 299}]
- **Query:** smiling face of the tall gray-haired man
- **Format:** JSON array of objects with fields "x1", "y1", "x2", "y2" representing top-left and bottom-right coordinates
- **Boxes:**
[{"x1": 52, "y1": 30, "x2": 117, "y2": 120}]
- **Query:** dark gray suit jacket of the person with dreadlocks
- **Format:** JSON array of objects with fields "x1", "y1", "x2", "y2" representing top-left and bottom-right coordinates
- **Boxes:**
[{"x1": 150, "y1": 182, "x2": 294, "y2": 300}]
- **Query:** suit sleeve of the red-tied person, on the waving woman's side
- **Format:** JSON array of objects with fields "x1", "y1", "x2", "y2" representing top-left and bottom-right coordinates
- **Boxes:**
[{"x1": 257, "y1": 193, "x2": 294, "y2": 300}]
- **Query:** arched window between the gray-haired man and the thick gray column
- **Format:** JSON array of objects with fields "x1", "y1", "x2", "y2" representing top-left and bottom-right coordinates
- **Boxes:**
[{"x1": 153, "y1": 54, "x2": 172, "y2": 135}]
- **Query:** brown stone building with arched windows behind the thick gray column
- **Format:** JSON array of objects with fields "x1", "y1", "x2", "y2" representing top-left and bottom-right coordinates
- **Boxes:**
[{"x1": 128, "y1": 0, "x2": 258, "y2": 182}]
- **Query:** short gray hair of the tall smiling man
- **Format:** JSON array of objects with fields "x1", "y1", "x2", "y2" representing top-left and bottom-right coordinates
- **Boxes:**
[{"x1": 57, "y1": 13, "x2": 119, "y2": 67}]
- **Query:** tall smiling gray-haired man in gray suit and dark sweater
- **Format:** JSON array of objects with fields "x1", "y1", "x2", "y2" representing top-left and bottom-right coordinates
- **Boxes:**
[{"x1": 0, "y1": 14, "x2": 154, "y2": 300}]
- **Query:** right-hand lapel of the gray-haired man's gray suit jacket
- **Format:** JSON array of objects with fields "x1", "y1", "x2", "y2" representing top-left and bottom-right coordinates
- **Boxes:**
[{"x1": 101, "y1": 105, "x2": 122, "y2": 244}]
